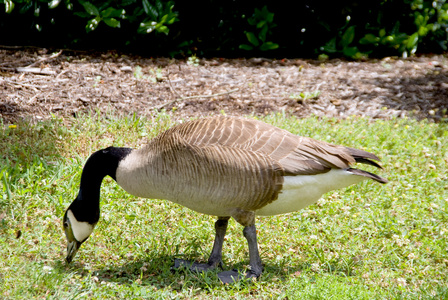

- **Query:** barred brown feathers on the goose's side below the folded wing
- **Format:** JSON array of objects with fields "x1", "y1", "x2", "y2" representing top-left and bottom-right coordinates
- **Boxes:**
[{"x1": 143, "y1": 126, "x2": 284, "y2": 211}]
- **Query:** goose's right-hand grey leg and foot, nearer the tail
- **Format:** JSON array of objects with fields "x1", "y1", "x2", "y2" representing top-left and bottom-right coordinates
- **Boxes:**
[{"x1": 218, "y1": 225, "x2": 263, "y2": 283}]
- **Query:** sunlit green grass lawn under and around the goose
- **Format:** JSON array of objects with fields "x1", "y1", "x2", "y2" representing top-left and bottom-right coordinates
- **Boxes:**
[{"x1": 0, "y1": 114, "x2": 448, "y2": 299}]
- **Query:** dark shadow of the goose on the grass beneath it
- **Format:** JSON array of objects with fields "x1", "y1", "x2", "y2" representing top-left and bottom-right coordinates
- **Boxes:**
[{"x1": 55, "y1": 255, "x2": 353, "y2": 290}]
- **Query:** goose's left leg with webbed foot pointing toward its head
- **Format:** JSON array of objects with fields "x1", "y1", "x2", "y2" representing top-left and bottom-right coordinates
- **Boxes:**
[{"x1": 173, "y1": 217, "x2": 230, "y2": 272}]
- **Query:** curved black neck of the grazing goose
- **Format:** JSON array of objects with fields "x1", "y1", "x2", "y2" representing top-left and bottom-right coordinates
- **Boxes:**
[{"x1": 69, "y1": 147, "x2": 132, "y2": 224}]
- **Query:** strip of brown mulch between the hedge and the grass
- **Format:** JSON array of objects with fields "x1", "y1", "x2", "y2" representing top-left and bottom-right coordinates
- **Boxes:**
[{"x1": 0, "y1": 49, "x2": 448, "y2": 124}]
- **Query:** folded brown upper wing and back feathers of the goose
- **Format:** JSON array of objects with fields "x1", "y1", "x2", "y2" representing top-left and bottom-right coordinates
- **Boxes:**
[{"x1": 163, "y1": 116, "x2": 378, "y2": 175}]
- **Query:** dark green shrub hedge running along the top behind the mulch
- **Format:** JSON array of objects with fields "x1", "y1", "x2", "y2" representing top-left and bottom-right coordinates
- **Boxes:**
[{"x1": 0, "y1": 0, "x2": 448, "y2": 59}]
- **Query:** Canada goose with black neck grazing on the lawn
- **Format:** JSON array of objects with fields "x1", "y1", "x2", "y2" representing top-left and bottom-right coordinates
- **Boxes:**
[{"x1": 63, "y1": 116, "x2": 387, "y2": 282}]
